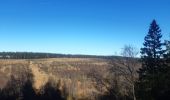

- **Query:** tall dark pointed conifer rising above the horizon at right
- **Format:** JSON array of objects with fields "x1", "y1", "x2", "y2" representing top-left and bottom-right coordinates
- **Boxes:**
[{"x1": 137, "y1": 20, "x2": 165, "y2": 100}]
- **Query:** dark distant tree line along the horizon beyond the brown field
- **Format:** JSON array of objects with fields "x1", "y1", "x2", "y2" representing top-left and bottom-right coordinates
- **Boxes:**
[{"x1": 0, "y1": 52, "x2": 117, "y2": 59}]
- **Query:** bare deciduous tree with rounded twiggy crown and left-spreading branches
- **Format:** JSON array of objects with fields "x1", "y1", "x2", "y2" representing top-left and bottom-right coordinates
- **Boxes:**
[{"x1": 111, "y1": 45, "x2": 140, "y2": 100}]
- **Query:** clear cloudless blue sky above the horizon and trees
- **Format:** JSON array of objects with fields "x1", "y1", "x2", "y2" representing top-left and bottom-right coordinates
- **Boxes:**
[{"x1": 0, "y1": 0, "x2": 170, "y2": 55}]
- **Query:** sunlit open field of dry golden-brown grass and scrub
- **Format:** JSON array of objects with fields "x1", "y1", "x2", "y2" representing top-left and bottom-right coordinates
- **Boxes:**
[{"x1": 0, "y1": 58, "x2": 141, "y2": 99}]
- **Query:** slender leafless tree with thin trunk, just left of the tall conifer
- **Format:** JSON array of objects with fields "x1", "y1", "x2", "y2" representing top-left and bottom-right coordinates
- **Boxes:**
[{"x1": 119, "y1": 45, "x2": 139, "y2": 100}]
